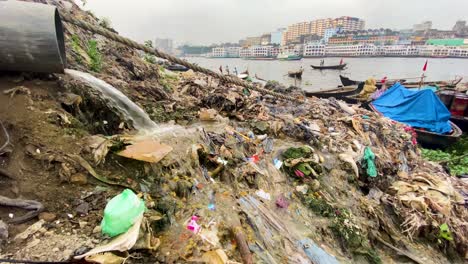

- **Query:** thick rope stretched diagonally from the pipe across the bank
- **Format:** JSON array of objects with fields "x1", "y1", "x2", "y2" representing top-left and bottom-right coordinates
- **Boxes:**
[{"x1": 60, "y1": 12, "x2": 303, "y2": 103}]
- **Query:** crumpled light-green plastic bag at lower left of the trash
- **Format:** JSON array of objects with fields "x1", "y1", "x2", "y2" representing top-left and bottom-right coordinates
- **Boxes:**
[{"x1": 101, "y1": 189, "x2": 146, "y2": 237}]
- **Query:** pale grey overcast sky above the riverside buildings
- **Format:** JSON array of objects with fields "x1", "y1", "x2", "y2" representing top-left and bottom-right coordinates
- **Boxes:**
[{"x1": 84, "y1": 0, "x2": 468, "y2": 44}]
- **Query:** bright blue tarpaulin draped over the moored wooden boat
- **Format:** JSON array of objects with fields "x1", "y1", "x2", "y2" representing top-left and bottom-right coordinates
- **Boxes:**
[{"x1": 372, "y1": 83, "x2": 452, "y2": 134}]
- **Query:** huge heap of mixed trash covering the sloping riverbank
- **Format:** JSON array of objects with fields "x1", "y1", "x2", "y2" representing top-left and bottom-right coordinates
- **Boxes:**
[{"x1": 0, "y1": 1, "x2": 468, "y2": 264}]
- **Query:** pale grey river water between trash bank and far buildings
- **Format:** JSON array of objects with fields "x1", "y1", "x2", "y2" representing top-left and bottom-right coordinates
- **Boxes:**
[{"x1": 185, "y1": 57, "x2": 468, "y2": 91}]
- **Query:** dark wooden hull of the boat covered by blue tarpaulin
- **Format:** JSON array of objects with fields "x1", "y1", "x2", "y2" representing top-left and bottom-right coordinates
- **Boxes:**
[{"x1": 369, "y1": 103, "x2": 463, "y2": 149}]
